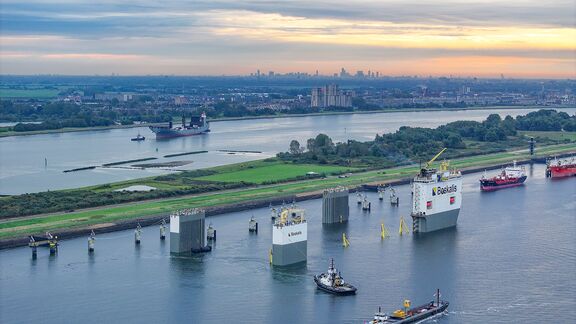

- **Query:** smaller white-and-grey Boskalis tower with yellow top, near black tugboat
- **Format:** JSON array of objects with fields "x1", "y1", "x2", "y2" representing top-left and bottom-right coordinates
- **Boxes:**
[{"x1": 270, "y1": 206, "x2": 308, "y2": 266}]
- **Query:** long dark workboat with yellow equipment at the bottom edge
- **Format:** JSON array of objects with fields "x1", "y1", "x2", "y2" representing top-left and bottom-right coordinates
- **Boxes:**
[{"x1": 370, "y1": 289, "x2": 450, "y2": 324}]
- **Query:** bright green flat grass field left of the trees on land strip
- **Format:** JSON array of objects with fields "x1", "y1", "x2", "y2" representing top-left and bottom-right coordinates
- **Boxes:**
[{"x1": 197, "y1": 162, "x2": 354, "y2": 184}]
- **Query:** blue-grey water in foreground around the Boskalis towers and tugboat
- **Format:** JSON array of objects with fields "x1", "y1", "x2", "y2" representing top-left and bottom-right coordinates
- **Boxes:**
[{"x1": 0, "y1": 165, "x2": 576, "y2": 323}]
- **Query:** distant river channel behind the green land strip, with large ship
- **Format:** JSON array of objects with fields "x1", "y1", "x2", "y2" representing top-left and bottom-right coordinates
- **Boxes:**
[{"x1": 0, "y1": 108, "x2": 576, "y2": 194}]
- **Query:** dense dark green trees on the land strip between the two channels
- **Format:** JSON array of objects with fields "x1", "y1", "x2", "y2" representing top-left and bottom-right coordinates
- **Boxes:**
[{"x1": 278, "y1": 110, "x2": 576, "y2": 165}]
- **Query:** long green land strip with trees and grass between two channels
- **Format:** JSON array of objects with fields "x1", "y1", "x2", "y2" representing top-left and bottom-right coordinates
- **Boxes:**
[{"x1": 0, "y1": 110, "x2": 576, "y2": 247}]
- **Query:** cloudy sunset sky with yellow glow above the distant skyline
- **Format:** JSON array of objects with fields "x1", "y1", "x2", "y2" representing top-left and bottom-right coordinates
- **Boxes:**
[{"x1": 0, "y1": 0, "x2": 576, "y2": 79}]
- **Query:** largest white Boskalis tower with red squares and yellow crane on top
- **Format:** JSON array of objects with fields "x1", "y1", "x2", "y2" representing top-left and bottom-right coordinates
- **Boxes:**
[{"x1": 411, "y1": 148, "x2": 462, "y2": 233}]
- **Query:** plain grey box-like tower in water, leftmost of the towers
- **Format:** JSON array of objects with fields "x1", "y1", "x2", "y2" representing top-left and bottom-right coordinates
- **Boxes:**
[{"x1": 170, "y1": 209, "x2": 211, "y2": 254}]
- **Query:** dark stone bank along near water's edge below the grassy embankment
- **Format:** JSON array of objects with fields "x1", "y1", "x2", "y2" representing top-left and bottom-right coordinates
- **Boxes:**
[{"x1": 0, "y1": 151, "x2": 576, "y2": 250}]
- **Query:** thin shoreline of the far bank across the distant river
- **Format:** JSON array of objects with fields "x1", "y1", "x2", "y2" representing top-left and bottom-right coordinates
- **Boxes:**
[{"x1": 0, "y1": 106, "x2": 576, "y2": 138}]
